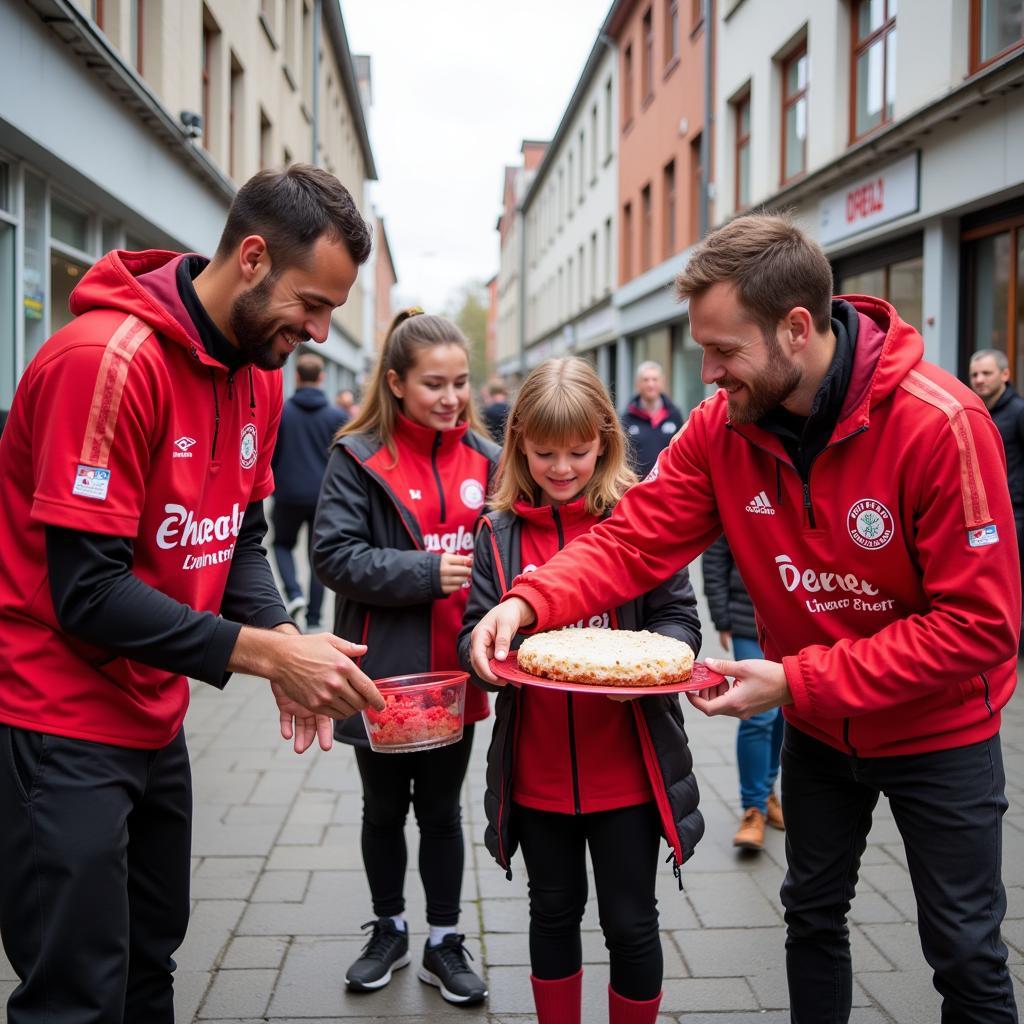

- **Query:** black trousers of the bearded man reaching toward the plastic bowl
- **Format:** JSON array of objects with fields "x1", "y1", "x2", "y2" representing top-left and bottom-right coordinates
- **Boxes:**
[{"x1": 0, "y1": 725, "x2": 191, "y2": 1024}]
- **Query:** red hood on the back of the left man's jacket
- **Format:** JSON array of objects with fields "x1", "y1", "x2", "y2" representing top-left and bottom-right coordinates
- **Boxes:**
[{"x1": 70, "y1": 249, "x2": 223, "y2": 368}]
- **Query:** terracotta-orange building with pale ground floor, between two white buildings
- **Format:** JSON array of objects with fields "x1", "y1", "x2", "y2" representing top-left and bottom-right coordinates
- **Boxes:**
[{"x1": 609, "y1": 0, "x2": 716, "y2": 409}]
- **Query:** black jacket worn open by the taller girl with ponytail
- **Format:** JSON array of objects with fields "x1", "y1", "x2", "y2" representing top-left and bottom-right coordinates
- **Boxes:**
[{"x1": 312, "y1": 431, "x2": 501, "y2": 746}]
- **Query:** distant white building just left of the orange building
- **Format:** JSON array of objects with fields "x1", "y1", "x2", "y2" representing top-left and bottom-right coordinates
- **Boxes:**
[{"x1": 522, "y1": 35, "x2": 618, "y2": 387}]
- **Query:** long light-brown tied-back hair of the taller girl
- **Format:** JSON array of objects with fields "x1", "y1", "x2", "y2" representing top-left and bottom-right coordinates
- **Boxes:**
[{"x1": 335, "y1": 306, "x2": 490, "y2": 464}]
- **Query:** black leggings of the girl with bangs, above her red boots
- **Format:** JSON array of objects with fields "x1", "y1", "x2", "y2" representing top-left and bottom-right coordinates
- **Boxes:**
[{"x1": 514, "y1": 803, "x2": 663, "y2": 1000}]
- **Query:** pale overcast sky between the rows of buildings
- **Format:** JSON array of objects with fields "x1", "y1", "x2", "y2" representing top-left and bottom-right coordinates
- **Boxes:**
[{"x1": 341, "y1": 0, "x2": 609, "y2": 311}]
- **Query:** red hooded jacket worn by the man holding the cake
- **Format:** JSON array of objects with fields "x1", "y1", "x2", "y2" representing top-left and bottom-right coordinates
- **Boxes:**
[{"x1": 509, "y1": 296, "x2": 1021, "y2": 757}]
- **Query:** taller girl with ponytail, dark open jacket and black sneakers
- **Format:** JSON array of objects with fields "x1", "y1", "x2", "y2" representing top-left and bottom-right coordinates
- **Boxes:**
[{"x1": 313, "y1": 310, "x2": 499, "y2": 1004}]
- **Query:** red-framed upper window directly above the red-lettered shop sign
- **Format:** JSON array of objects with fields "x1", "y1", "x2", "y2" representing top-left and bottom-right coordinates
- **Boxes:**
[{"x1": 850, "y1": 0, "x2": 896, "y2": 142}]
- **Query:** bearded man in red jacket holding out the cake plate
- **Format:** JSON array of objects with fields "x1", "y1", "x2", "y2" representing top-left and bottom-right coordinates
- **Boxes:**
[{"x1": 473, "y1": 215, "x2": 1021, "y2": 1024}]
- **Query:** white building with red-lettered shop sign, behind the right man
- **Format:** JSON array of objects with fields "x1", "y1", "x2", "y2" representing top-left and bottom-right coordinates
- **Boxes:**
[{"x1": 715, "y1": 0, "x2": 1024, "y2": 382}]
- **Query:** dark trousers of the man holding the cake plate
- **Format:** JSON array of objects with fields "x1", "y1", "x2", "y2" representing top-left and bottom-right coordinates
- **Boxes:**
[{"x1": 781, "y1": 724, "x2": 1017, "y2": 1024}]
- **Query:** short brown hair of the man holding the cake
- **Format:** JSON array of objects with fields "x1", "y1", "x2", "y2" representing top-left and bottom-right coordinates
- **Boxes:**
[{"x1": 676, "y1": 213, "x2": 833, "y2": 337}]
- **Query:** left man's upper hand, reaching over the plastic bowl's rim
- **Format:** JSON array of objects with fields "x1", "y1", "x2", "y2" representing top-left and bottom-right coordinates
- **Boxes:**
[{"x1": 227, "y1": 626, "x2": 384, "y2": 718}]
